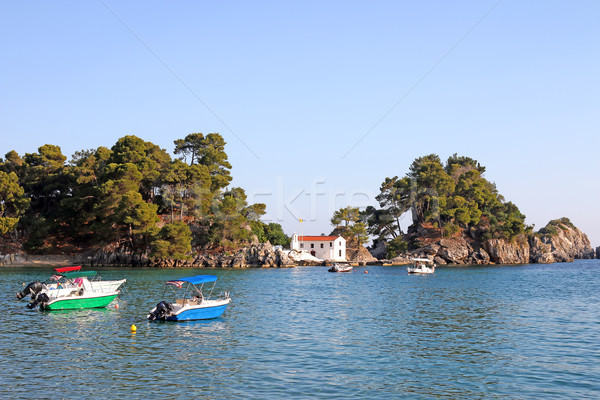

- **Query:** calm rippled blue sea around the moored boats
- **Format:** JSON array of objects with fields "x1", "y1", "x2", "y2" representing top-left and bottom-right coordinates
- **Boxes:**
[{"x1": 0, "y1": 260, "x2": 600, "y2": 399}]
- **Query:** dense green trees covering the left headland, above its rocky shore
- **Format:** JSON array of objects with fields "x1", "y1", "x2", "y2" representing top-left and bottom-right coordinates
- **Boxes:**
[{"x1": 0, "y1": 133, "x2": 289, "y2": 259}]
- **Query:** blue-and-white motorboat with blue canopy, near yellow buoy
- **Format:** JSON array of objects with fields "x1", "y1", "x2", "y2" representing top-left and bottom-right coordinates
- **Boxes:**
[{"x1": 148, "y1": 275, "x2": 231, "y2": 321}]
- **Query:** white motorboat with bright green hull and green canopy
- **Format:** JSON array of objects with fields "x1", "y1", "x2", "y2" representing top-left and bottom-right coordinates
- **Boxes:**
[{"x1": 28, "y1": 271, "x2": 126, "y2": 311}]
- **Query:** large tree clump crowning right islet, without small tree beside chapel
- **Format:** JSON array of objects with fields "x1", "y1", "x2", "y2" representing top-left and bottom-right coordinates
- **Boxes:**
[{"x1": 361, "y1": 154, "x2": 528, "y2": 243}]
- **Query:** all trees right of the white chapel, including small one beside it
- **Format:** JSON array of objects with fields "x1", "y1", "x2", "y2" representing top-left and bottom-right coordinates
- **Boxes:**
[{"x1": 331, "y1": 154, "x2": 532, "y2": 258}]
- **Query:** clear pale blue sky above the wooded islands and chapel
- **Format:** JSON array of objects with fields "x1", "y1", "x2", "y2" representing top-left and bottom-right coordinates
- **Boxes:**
[{"x1": 0, "y1": 0, "x2": 600, "y2": 247}]
